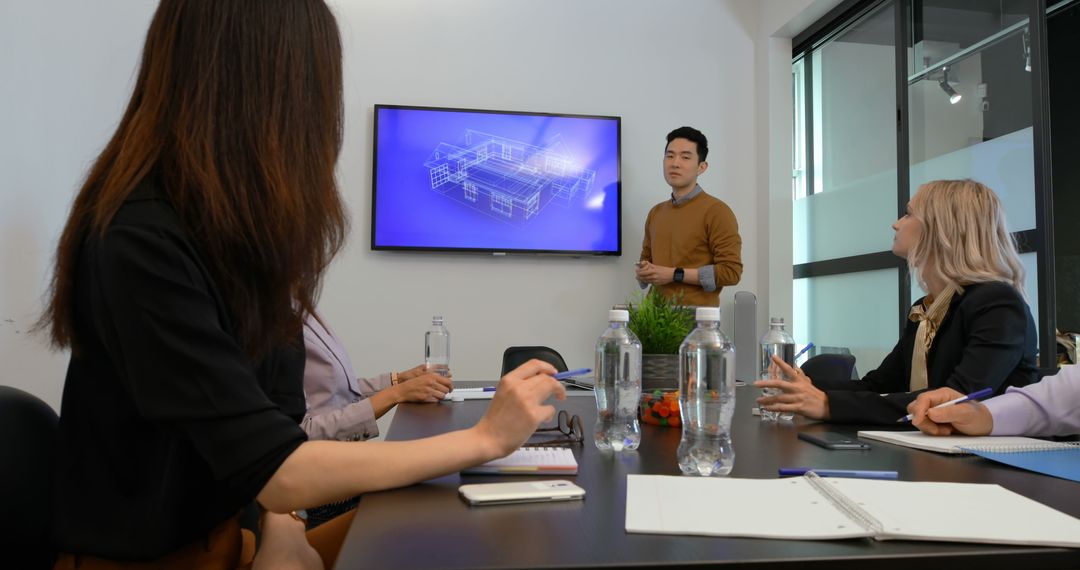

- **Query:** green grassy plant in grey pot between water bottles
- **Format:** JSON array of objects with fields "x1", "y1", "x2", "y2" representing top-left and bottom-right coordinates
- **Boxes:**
[{"x1": 627, "y1": 288, "x2": 694, "y2": 392}]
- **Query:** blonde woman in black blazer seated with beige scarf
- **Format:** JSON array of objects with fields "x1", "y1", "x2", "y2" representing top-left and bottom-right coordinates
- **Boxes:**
[{"x1": 755, "y1": 180, "x2": 1038, "y2": 424}]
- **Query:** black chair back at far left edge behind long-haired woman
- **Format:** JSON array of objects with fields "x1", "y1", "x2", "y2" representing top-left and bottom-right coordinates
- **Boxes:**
[{"x1": 0, "y1": 385, "x2": 58, "y2": 568}]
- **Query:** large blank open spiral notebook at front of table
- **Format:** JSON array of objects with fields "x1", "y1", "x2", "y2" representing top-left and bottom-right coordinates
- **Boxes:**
[{"x1": 626, "y1": 474, "x2": 1080, "y2": 547}]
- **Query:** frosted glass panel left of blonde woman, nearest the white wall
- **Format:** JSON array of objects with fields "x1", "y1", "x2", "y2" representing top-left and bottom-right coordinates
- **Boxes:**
[{"x1": 793, "y1": 2, "x2": 901, "y2": 370}]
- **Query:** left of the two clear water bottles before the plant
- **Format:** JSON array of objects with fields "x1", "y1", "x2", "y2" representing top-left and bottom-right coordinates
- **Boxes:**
[{"x1": 593, "y1": 309, "x2": 642, "y2": 451}]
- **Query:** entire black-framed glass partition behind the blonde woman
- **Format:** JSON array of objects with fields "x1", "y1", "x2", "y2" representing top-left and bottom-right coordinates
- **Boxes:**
[{"x1": 793, "y1": 0, "x2": 1068, "y2": 372}]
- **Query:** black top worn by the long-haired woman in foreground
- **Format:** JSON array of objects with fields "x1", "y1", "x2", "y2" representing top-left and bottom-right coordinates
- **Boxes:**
[{"x1": 53, "y1": 182, "x2": 306, "y2": 560}]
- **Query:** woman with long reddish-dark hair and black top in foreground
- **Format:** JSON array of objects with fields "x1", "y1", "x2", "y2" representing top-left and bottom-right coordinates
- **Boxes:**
[{"x1": 41, "y1": 0, "x2": 563, "y2": 569}]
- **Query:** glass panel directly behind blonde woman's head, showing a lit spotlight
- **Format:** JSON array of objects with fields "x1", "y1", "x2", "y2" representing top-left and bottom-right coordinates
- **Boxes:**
[{"x1": 907, "y1": 0, "x2": 1039, "y2": 334}]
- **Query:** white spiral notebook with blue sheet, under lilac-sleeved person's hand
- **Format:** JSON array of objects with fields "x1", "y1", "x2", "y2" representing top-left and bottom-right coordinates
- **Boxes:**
[{"x1": 859, "y1": 432, "x2": 1080, "y2": 481}]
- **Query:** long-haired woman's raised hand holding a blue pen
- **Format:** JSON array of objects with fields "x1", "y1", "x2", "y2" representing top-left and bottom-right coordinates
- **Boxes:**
[{"x1": 474, "y1": 358, "x2": 566, "y2": 459}]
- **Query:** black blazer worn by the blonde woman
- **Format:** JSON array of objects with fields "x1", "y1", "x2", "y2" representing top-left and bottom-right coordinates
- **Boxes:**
[{"x1": 814, "y1": 282, "x2": 1039, "y2": 425}]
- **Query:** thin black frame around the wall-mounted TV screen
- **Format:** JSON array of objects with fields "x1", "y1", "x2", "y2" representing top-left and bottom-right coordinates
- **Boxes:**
[{"x1": 370, "y1": 104, "x2": 622, "y2": 257}]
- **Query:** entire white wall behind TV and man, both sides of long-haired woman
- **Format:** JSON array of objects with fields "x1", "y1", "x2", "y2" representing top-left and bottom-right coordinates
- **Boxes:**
[{"x1": 0, "y1": 0, "x2": 836, "y2": 406}]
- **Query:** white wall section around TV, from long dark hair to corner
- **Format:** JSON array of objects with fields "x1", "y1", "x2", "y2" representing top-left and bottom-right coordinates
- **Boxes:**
[{"x1": 322, "y1": 0, "x2": 758, "y2": 386}]
